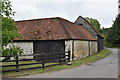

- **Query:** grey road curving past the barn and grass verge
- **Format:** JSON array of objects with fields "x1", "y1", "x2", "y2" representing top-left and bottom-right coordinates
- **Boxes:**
[{"x1": 19, "y1": 48, "x2": 118, "y2": 78}]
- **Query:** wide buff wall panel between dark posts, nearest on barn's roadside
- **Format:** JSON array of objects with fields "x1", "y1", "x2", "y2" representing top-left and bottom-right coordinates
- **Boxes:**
[{"x1": 74, "y1": 40, "x2": 89, "y2": 59}]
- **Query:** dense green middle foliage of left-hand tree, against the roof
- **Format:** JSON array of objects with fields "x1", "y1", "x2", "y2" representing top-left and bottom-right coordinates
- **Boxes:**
[{"x1": 2, "y1": 17, "x2": 21, "y2": 46}]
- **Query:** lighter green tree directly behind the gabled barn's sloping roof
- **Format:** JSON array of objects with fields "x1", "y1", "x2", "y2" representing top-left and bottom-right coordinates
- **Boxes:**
[{"x1": 85, "y1": 17, "x2": 103, "y2": 34}]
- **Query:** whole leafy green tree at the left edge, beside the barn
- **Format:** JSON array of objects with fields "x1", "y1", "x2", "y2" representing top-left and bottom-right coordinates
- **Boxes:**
[{"x1": 0, "y1": 0, "x2": 22, "y2": 60}]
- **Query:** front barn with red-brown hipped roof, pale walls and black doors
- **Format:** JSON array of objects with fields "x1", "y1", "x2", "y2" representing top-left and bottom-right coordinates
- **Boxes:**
[{"x1": 14, "y1": 17, "x2": 97, "y2": 59}]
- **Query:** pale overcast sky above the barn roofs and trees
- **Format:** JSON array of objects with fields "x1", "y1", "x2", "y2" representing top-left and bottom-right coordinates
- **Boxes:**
[{"x1": 11, "y1": 0, "x2": 118, "y2": 27}]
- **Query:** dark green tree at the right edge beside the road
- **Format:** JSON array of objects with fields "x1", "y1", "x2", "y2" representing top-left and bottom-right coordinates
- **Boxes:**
[{"x1": 107, "y1": 14, "x2": 120, "y2": 47}]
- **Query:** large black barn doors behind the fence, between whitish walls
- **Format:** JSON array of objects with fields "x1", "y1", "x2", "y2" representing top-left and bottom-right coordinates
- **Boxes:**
[{"x1": 33, "y1": 40, "x2": 65, "y2": 61}]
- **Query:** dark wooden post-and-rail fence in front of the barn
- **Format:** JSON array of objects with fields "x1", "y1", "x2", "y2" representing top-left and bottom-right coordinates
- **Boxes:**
[{"x1": 0, "y1": 51, "x2": 70, "y2": 72}]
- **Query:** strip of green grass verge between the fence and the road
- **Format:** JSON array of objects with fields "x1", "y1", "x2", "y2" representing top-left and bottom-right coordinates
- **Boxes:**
[{"x1": 2, "y1": 49, "x2": 111, "y2": 77}]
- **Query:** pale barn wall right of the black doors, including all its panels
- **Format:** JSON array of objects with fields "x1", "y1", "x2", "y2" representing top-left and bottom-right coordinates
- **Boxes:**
[{"x1": 65, "y1": 40, "x2": 97, "y2": 60}]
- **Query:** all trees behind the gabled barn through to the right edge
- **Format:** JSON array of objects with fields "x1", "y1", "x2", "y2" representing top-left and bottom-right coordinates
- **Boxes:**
[{"x1": 86, "y1": 14, "x2": 120, "y2": 47}]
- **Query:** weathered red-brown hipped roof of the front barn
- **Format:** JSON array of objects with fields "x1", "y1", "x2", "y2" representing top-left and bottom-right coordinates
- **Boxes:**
[{"x1": 16, "y1": 17, "x2": 96, "y2": 40}]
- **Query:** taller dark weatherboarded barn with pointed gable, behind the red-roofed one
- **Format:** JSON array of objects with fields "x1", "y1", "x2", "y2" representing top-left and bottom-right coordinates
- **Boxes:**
[{"x1": 75, "y1": 16, "x2": 104, "y2": 52}]
